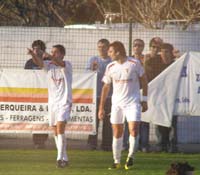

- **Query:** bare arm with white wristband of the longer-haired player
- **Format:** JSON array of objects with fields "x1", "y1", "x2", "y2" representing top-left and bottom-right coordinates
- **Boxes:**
[{"x1": 140, "y1": 74, "x2": 148, "y2": 112}]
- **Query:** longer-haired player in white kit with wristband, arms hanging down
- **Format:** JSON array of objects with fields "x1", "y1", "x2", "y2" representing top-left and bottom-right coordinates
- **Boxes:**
[{"x1": 98, "y1": 41, "x2": 148, "y2": 170}]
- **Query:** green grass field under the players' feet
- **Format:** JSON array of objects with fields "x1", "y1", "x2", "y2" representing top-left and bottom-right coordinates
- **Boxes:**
[{"x1": 0, "y1": 149, "x2": 200, "y2": 175}]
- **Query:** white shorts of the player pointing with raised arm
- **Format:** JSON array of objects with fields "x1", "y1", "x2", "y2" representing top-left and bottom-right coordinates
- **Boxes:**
[{"x1": 49, "y1": 104, "x2": 71, "y2": 126}]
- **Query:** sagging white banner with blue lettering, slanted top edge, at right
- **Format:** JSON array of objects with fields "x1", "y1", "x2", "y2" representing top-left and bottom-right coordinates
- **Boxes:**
[{"x1": 142, "y1": 52, "x2": 200, "y2": 127}]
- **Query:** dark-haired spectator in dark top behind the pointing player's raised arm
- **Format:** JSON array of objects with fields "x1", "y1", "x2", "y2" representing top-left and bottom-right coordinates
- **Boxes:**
[{"x1": 24, "y1": 40, "x2": 49, "y2": 149}]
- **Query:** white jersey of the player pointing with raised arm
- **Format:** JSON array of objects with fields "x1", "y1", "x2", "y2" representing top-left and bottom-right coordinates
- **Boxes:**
[{"x1": 44, "y1": 61, "x2": 72, "y2": 107}]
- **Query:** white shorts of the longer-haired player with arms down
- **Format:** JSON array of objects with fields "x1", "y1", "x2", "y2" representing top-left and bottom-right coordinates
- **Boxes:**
[{"x1": 110, "y1": 103, "x2": 141, "y2": 124}]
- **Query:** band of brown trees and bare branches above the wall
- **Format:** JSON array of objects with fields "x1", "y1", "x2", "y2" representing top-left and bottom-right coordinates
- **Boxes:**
[{"x1": 0, "y1": 0, "x2": 200, "y2": 28}]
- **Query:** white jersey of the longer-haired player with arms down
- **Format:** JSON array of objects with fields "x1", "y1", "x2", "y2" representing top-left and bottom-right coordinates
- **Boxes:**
[{"x1": 102, "y1": 57, "x2": 144, "y2": 106}]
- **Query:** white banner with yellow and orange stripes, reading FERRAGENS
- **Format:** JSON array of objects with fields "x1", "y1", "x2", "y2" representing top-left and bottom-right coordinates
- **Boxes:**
[{"x1": 0, "y1": 69, "x2": 96, "y2": 134}]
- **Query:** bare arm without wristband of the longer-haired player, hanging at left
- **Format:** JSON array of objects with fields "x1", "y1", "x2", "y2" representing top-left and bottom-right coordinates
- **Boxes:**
[{"x1": 98, "y1": 84, "x2": 110, "y2": 120}]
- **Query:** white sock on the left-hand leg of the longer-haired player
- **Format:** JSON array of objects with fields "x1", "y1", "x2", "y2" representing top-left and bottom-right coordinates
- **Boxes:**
[{"x1": 112, "y1": 137, "x2": 123, "y2": 163}]
